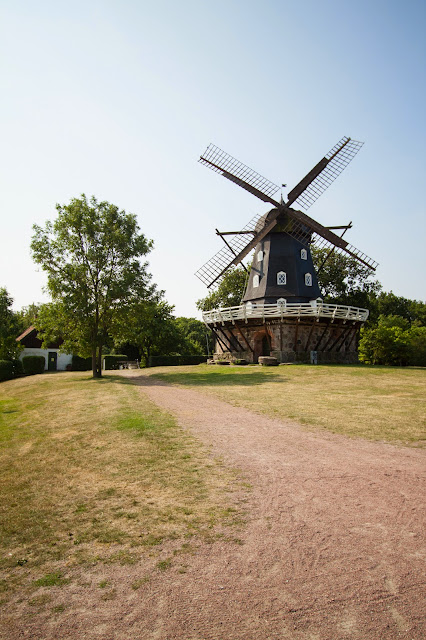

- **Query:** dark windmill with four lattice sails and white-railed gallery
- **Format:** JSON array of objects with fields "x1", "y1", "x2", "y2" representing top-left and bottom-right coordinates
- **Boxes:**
[{"x1": 196, "y1": 136, "x2": 377, "y2": 361}]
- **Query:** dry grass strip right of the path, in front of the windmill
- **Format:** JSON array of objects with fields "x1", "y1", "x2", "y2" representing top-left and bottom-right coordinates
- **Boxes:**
[{"x1": 149, "y1": 365, "x2": 426, "y2": 446}]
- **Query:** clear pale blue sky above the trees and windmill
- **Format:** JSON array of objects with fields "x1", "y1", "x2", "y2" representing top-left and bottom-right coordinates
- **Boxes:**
[{"x1": 0, "y1": 0, "x2": 426, "y2": 316}]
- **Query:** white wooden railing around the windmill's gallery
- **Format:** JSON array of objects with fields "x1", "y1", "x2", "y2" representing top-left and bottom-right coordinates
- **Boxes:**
[{"x1": 203, "y1": 300, "x2": 369, "y2": 324}]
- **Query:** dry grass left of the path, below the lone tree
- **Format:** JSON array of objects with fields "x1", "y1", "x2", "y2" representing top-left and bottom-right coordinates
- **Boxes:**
[{"x1": 0, "y1": 372, "x2": 243, "y2": 606}]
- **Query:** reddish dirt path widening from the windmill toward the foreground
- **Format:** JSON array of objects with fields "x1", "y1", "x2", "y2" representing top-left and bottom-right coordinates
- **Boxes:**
[{"x1": 5, "y1": 371, "x2": 426, "y2": 640}]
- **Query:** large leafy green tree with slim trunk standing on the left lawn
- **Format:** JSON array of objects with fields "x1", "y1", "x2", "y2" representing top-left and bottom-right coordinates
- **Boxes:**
[{"x1": 31, "y1": 194, "x2": 152, "y2": 377}]
